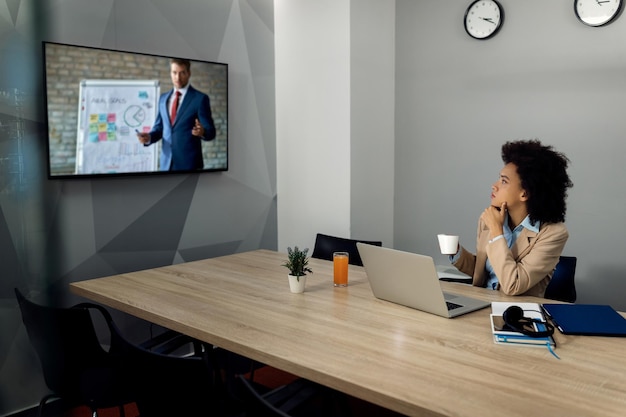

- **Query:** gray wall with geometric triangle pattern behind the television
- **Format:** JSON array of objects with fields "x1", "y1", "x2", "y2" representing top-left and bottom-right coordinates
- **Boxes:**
[{"x1": 0, "y1": 0, "x2": 277, "y2": 415}]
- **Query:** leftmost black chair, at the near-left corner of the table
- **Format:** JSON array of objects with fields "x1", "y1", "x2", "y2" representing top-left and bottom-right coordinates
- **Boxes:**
[{"x1": 15, "y1": 288, "x2": 132, "y2": 416}]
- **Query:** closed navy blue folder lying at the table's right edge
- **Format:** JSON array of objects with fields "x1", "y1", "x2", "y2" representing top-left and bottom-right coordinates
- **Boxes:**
[{"x1": 542, "y1": 304, "x2": 626, "y2": 336}]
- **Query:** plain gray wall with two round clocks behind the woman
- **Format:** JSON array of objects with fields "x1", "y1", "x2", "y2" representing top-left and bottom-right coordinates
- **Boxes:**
[{"x1": 394, "y1": 0, "x2": 626, "y2": 310}]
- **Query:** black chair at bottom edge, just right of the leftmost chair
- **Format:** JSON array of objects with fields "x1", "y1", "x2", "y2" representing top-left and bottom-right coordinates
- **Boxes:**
[{"x1": 111, "y1": 318, "x2": 226, "y2": 417}]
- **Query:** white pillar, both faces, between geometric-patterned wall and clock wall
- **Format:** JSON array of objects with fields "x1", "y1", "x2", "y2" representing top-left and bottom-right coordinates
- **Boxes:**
[{"x1": 274, "y1": 0, "x2": 395, "y2": 250}]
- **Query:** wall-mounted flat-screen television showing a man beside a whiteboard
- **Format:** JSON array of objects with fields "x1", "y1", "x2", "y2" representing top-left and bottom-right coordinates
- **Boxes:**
[{"x1": 43, "y1": 42, "x2": 228, "y2": 178}]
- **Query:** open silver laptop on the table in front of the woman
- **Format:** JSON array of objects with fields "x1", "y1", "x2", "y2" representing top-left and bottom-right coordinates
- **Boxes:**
[{"x1": 357, "y1": 242, "x2": 491, "y2": 318}]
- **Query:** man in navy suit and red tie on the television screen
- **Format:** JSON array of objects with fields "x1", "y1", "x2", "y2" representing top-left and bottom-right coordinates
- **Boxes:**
[{"x1": 137, "y1": 58, "x2": 215, "y2": 171}]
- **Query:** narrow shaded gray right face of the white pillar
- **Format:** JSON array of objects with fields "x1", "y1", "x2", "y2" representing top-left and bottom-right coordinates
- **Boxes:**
[{"x1": 350, "y1": 0, "x2": 396, "y2": 246}]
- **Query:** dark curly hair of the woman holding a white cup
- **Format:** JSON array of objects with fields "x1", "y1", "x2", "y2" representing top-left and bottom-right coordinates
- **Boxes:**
[{"x1": 502, "y1": 140, "x2": 574, "y2": 223}]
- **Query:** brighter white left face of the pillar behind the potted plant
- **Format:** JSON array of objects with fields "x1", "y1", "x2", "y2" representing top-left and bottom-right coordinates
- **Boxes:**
[{"x1": 274, "y1": 0, "x2": 350, "y2": 251}]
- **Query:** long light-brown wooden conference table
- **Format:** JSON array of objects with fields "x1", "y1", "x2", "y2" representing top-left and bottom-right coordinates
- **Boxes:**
[{"x1": 70, "y1": 250, "x2": 626, "y2": 417}]
